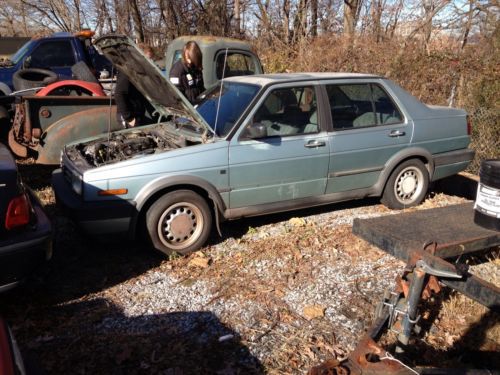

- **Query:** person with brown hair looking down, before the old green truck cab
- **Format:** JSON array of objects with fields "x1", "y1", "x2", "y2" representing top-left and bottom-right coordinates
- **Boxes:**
[{"x1": 169, "y1": 41, "x2": 205, "y2": 104}]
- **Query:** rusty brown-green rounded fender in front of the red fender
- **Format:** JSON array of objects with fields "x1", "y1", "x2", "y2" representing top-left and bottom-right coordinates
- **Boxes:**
[{"x1": 34, "y1": 106, "x2": 122, "y2": 164}]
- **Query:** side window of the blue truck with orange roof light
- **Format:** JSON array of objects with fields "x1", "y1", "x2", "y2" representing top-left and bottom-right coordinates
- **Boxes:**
[{"x1": 30, "y1": 40, "x2": 75, "y2": 68}]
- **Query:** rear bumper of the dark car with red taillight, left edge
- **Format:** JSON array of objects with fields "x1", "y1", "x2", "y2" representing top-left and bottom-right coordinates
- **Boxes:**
[{"x1": 0, "y1": 195, "x2": 52, "y2": 292}]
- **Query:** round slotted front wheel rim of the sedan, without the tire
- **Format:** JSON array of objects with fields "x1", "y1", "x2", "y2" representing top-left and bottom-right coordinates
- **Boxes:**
[{"x1": 158, "y1": 202, "x2": 203, "y2": 250}]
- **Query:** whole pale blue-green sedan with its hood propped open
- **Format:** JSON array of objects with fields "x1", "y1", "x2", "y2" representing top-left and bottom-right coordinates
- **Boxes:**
[{"x1": 52, "y1": 36, "x2": 474, "y2": 254}]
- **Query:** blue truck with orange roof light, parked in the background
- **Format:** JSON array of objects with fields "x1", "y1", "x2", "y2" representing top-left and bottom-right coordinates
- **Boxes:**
[{"x1": 0, "y1": 30, "x2": 110, "y2": 95}]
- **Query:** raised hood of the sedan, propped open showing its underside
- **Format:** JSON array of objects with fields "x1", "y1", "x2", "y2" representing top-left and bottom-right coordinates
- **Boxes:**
[{"x1": 94, "y1": 35, "x2": 214, "y2": 135}]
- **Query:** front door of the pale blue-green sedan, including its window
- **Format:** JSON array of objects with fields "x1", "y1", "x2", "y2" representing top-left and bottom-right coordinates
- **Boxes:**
[{"x1": 229, "y1": 83, "x2": 329, "y2": 208}]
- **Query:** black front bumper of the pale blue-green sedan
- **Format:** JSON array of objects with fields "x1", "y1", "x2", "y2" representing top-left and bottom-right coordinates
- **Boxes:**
[{"x1": 52, "y1": 169, "x2": 137, "y2": 239}]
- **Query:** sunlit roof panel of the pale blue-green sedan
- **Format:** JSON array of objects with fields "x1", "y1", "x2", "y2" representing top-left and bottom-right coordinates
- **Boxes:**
[{"x1": 225, "y1": 72, "x2": 383, "y2": 86}]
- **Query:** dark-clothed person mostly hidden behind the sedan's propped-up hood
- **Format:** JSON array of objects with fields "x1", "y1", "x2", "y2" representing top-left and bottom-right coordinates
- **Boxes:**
[{"x1": 115, "y1": 44, "x2": 153, "y2": 128}]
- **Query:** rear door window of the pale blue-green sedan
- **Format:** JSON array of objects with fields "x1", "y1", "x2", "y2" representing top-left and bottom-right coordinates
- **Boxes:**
[{"x1": 326, "y1": 83, "x2": 403, "y2": 130}]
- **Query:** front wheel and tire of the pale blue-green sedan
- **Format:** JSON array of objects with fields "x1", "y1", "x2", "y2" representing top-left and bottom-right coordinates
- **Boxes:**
[{"x1": 145, "y1": 190, "x2": 212, "y2": 255}]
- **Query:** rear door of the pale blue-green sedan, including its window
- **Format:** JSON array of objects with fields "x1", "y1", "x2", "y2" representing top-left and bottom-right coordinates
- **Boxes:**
[{"x1": 325, "y1": 81, "x2": 412, "y2": 193}]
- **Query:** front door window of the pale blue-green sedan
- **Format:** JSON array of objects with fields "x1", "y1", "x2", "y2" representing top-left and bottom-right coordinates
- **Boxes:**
[{"x1": 246, "y1": 86, "x2": 319, "y2": 138}]
